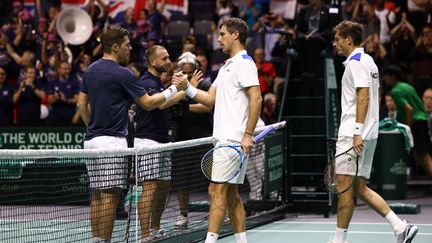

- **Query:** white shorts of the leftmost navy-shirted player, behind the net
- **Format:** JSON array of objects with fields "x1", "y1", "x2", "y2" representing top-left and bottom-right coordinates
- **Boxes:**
[{"x1": 84, "y1": 136, "x2": 128, "y2": 189}]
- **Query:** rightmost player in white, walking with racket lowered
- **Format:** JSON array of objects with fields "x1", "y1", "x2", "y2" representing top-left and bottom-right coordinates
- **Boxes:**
[{"x1": 329, "y1": 21, "x2": 417, "y2": 243}]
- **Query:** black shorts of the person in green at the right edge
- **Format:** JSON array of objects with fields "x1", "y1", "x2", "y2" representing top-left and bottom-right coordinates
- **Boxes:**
[{"x1": 411, "y1": 120, "x2": 432, "y2": 156}]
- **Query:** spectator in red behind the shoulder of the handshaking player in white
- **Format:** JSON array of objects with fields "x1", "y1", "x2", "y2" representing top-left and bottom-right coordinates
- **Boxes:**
[{"x1": 254, "y1": 48, "x2": 276, "y2": 94}]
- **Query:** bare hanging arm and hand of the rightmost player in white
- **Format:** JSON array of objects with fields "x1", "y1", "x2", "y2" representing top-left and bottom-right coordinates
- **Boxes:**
[{"x1": 353, "y1": 87, "x2": 369, "y2": 154}]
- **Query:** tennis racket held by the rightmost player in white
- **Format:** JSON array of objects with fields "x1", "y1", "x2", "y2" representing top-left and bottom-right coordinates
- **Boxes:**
[{"x1": 323, "y1": 120, "x2": 376, "y2": 194}]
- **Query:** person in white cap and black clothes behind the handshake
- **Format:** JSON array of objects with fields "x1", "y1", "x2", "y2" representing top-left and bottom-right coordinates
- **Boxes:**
[{"x1": 171, "y1": 52, "x2": 213, "y2": 228}]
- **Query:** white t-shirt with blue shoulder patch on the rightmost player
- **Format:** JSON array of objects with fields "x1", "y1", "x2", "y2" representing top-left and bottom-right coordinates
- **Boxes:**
[{"x1": 338, "y1": 48, "x2": 379, "y2": 139}]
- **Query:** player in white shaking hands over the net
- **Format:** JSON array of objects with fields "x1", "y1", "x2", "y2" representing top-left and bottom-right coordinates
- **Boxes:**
[{"x1": 177, "y1": 18, "x2": 262, "y2": 243}]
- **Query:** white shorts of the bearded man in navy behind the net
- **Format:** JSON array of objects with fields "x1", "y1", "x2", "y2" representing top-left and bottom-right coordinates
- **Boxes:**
[{"x1": 134, "y1": 138, "x2": 171, "y2": 182}]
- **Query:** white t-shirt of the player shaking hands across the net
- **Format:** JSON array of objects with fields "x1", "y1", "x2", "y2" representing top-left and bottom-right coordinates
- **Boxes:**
[{"x1": 213, "y1": 51, "x2": 259, "y2": 142}]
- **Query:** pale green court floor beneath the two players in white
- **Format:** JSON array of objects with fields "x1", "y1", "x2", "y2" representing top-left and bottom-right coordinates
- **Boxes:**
[{"x1": 218, "y1": 189, "x2": 432, "y2": 243}]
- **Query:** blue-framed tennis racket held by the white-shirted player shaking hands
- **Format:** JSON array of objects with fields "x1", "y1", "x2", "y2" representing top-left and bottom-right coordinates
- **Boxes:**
[{"x1": 201, "y1": 126, "x2": 274, "y2": 183}]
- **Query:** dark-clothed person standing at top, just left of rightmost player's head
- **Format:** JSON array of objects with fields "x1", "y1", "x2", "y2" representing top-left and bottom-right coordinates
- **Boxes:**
[{"x1": 296, "y1": 0, "x2": 333, "y2": 75}]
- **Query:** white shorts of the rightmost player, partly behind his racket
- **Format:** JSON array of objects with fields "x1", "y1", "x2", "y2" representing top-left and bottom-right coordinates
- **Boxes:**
[{"x1": 336, "y1": 137, "x2": 377, "y2": 179}]
